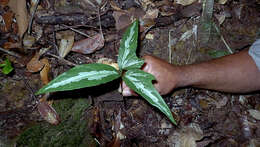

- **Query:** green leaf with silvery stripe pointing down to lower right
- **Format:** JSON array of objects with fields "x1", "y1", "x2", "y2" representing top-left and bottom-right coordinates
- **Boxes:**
[{"x1": 123, "y1": 69, "x2": 177, "y2": 125}]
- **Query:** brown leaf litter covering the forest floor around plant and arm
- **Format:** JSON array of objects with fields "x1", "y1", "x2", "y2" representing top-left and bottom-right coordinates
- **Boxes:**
[{"x1": 0, "y1": 0, "x2": 260, "y2": 146}]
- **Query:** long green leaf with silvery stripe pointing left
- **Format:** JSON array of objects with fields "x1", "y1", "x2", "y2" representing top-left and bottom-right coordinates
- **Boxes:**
[{"x1": 36, "y1": 63, "x2": 120, "y2": 94}]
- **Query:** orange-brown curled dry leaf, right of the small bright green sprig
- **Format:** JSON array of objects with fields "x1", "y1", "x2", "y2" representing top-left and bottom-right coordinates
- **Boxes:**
[{"x1": 26, "y1": 52, "x2": 44, "y2": 72}]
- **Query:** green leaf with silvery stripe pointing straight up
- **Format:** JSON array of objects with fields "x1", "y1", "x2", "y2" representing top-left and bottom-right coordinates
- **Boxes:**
[{"x1": 117, "y1": 20, "x2": 144, "y2": 71}]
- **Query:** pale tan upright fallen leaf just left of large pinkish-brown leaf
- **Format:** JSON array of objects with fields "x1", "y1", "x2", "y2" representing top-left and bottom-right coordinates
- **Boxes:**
[{"x1": 59, "y1": 35, "x2": 74, "y2": 58}]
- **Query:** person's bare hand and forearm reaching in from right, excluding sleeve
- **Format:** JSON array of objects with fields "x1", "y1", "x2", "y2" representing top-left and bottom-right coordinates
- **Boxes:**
[{"x1": 123, "y1": 50, "x2": 260, "y2": 96}]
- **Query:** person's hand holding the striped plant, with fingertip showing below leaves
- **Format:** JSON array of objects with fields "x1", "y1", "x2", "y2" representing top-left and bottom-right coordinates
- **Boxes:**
[{"x1": 122, "y1": 55, "x2": 179, "y2": 96}]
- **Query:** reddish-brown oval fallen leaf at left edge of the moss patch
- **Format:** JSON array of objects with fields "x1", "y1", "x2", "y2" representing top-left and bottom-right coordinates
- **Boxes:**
[{"x1": 37, "y1": 101, "x2": 60, "y2": 125}]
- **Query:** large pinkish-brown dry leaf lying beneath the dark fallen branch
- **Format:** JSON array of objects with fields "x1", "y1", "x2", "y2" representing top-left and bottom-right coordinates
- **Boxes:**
[{"x1": 72, "y1": 34, "x2": 105, "y2": 54}]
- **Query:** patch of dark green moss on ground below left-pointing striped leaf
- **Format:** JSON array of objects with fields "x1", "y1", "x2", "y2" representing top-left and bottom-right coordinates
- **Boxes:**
[{"x1": 17, "y1": 99, "x2": 95, "y2": 147}]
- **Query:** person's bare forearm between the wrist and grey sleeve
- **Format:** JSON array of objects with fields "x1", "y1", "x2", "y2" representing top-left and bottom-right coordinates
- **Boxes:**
[{"x1": 177, "y1": 51, "x2": 260, "y2": 93}]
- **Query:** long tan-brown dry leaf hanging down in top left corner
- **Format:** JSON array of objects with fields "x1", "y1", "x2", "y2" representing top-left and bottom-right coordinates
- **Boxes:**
[{"x1": 8, "y1": 0, "x2": 29, "y2": 38}]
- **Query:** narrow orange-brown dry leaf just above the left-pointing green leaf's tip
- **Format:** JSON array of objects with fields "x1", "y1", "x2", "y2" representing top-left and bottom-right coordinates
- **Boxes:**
[{"x1": 40, "y1": 58, "x2": 50, "y2": 85}]
